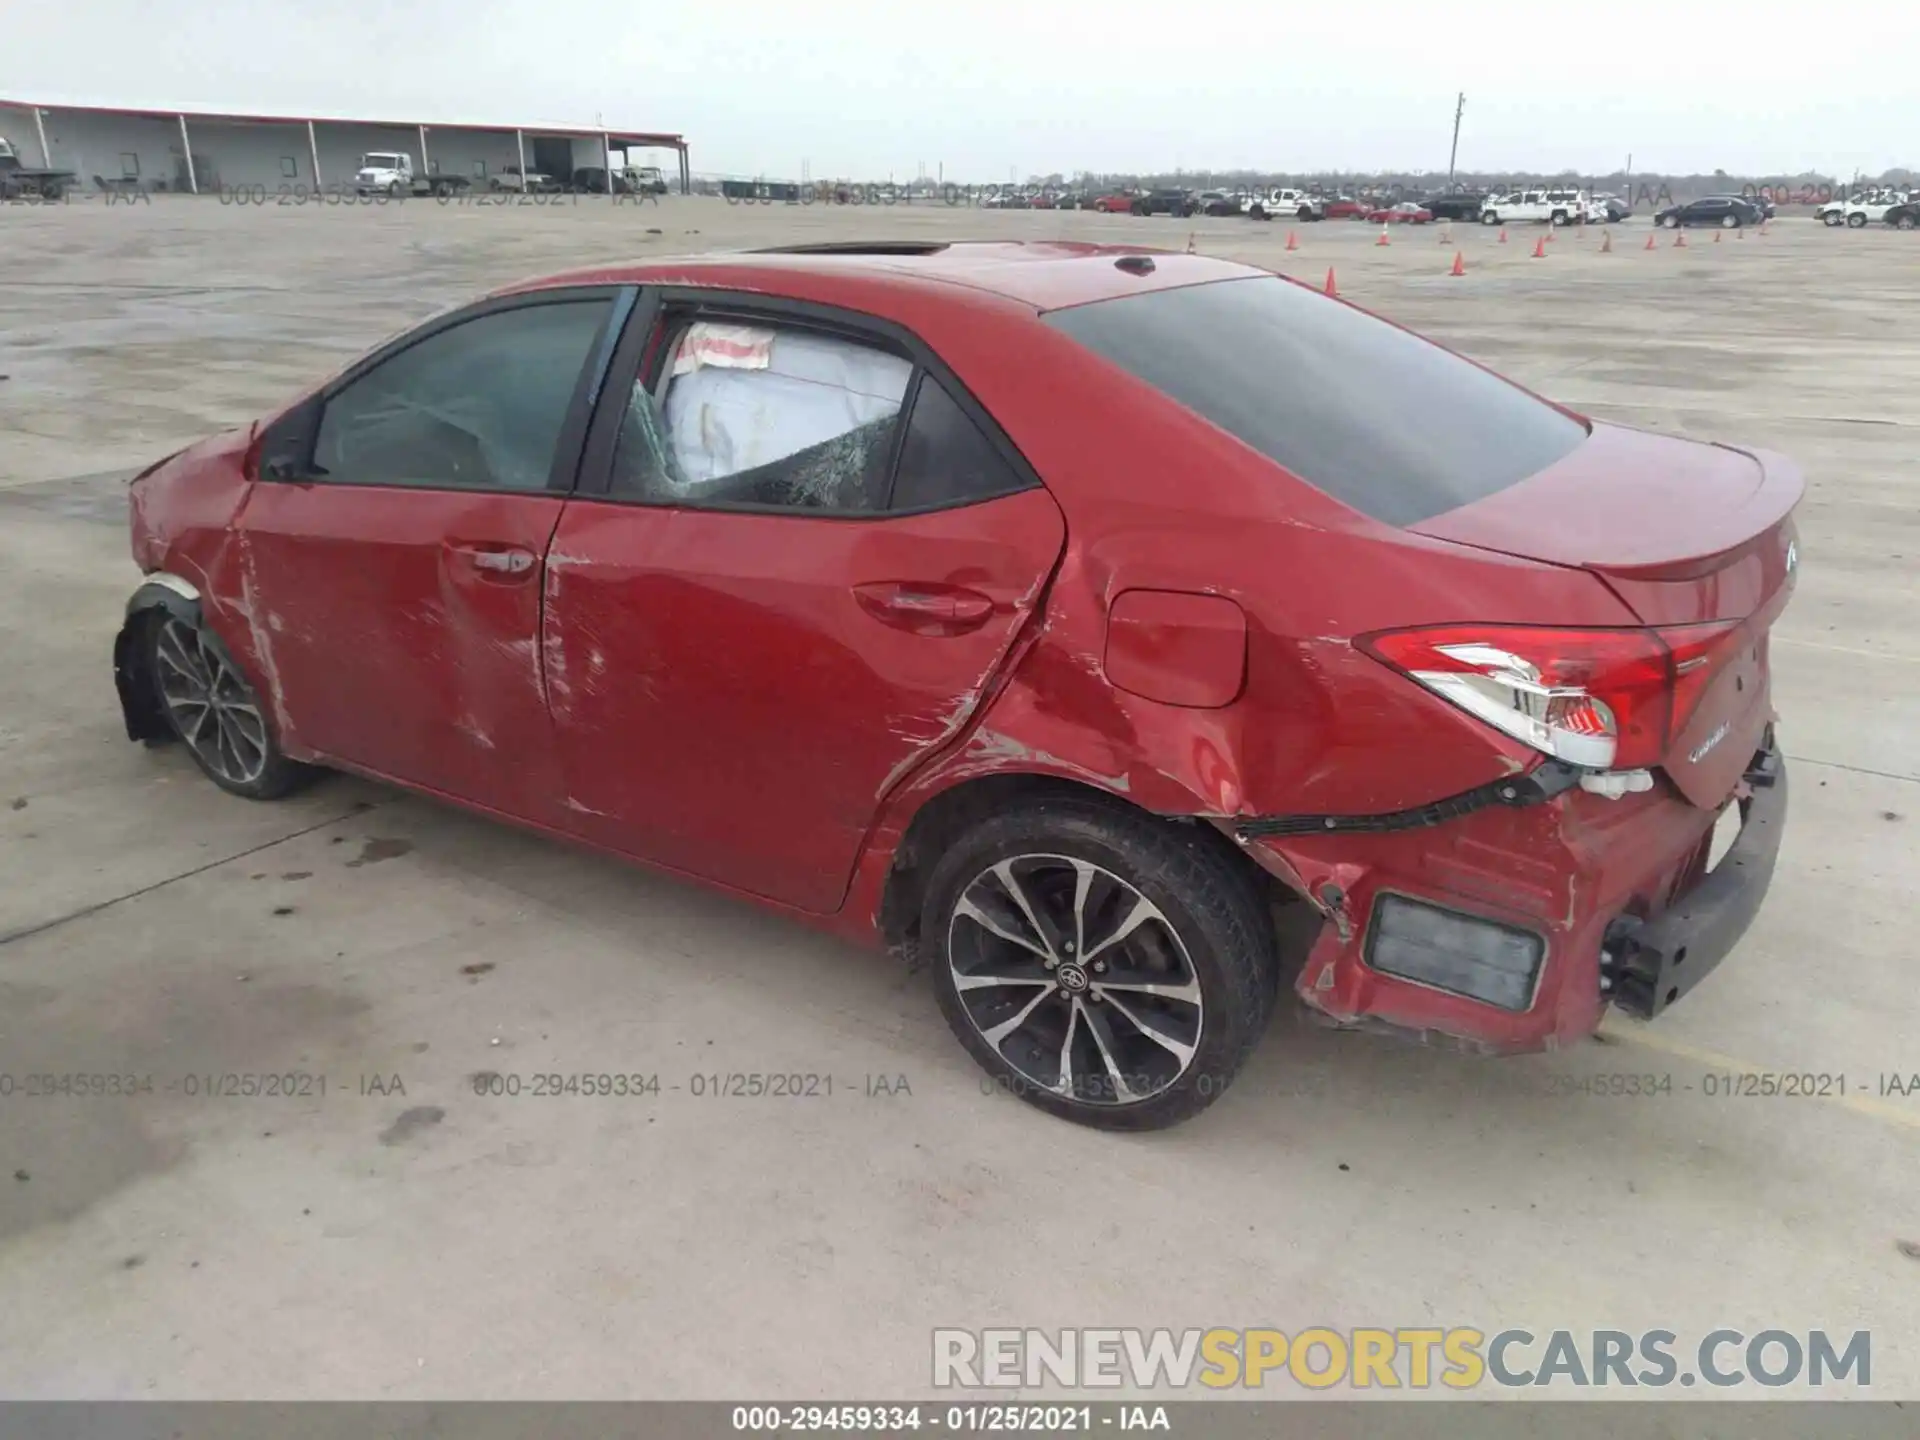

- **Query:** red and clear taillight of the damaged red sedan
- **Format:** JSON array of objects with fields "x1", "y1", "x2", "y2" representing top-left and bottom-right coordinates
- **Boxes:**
[{"x1": 1357, "y1": 620, "x2": 1740, "y2": 770}]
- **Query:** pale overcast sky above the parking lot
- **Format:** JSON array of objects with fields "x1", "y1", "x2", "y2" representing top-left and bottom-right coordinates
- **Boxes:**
[{"x1": 0, "y1": 0, "x2": 1920, "y2": 182}]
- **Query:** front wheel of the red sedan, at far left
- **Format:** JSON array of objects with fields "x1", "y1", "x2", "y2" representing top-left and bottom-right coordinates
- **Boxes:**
[{"x1": 146, "y1": 612, "x2": 317, "y2": 801}]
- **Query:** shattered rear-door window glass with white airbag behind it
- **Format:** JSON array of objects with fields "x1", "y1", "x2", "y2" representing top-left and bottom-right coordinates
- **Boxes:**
[{"x1": 612, "y1": 321, "x2": 912, "y2": 513}]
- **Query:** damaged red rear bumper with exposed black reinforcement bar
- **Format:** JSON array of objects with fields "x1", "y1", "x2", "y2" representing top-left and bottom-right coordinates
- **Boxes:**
[{"x1": 1242, "y1": 730, "x2": 1786, "y2": 1054}]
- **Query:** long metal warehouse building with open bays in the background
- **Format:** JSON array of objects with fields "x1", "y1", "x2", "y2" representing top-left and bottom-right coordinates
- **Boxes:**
[{"x1": 0, "y1": 98, "x2": 689, "y2": 194}]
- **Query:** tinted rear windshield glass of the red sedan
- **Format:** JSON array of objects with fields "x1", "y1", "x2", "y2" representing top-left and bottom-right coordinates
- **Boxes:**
[{"x1": 1046, "y1": 276, "x2": 1586, "y2": 524}]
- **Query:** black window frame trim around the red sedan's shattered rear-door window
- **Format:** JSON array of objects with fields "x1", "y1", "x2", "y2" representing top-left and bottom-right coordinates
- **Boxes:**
[{"x1": 574, "y1": 284, "x2": 1044, "y2": 524}]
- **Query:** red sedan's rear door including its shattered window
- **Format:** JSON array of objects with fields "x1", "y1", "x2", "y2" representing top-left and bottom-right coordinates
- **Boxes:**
[{"x1": 543, "y1": 292, "x2": 1066, "y2": 912}]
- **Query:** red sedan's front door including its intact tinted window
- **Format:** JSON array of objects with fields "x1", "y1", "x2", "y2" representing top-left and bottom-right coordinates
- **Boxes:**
[{"x1": 240, "y1": 288, "x2": 632, "y2": 820}]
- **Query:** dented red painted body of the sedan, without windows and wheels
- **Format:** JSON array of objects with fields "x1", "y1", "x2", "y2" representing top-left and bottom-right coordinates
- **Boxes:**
[{"x1": 121, "y1": 242, "x2": 1801, "y2": 1075}]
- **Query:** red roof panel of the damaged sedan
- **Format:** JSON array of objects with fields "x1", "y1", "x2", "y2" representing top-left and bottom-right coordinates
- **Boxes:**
[{"x1": 495, "y1": 240, "x2": 1269, "y2": 311}]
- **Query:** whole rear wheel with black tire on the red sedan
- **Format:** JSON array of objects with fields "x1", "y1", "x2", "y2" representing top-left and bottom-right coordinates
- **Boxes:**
[{"x1": 920, "y1": 799, "x2": 1277, "y2": 1131}]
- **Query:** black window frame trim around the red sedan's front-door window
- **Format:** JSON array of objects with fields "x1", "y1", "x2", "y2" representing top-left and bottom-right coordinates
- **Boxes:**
[{"x1": 259, "y1": 284, "x2": 639, "y2": 495}]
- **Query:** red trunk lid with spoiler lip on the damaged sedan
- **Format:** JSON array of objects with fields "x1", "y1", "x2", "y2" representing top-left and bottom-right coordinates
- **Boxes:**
[{"x1": 1411, "y1": 424, "x2": 1805, "y2": 806}]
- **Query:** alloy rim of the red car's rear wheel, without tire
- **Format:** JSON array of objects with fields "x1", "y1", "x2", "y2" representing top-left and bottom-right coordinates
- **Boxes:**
[{"x1": 947, "y1": 854, "x2": 1204, "y2": 1106}]
